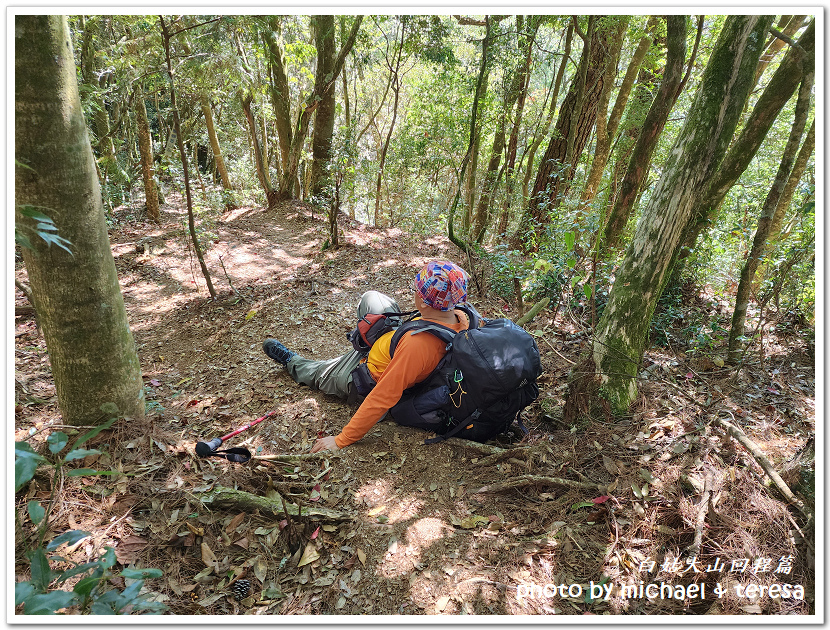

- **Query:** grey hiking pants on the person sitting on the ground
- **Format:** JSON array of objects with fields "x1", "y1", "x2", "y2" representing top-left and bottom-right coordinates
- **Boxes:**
[{"x1": 285, "y1": 291, "x2": 400, "y2": 398}]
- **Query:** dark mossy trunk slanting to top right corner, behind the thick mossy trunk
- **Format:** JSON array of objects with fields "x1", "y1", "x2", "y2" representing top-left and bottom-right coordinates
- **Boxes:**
[{"x1": 677, "y1": 20, "x2": 816, "y2": 259}]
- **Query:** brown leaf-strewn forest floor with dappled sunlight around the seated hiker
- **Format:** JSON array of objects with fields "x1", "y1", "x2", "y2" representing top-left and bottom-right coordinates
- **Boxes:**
[{"x1": 15, "y1": 195, "x2": 821, "y2": 615}]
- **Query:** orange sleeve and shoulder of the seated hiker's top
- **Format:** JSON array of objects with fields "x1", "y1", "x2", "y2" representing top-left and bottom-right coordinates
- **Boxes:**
[{"x1": 334, "y1": 310, "x2": 469, "y2": 448}]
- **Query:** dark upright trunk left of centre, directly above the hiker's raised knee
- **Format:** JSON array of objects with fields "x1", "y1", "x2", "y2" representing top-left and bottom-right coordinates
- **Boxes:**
[{"x1": 311, "y1": 15, "x2": 336, "y2": 200}]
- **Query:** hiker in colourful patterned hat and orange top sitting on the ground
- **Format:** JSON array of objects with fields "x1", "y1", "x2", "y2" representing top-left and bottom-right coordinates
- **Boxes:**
[{"x1": 262, "y1": 261, "x2": 469, "y2": 453}]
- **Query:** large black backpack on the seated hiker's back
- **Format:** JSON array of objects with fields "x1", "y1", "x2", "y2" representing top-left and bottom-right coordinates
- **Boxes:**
[{"x1": 390, "y1": 306, "x2": 542, "y2": 443}]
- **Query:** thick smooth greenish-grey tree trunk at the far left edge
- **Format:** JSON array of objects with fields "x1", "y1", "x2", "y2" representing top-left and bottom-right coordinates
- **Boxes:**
[{"x1": 14, "y1": 15, "x2": 144, "y2": 425}]
